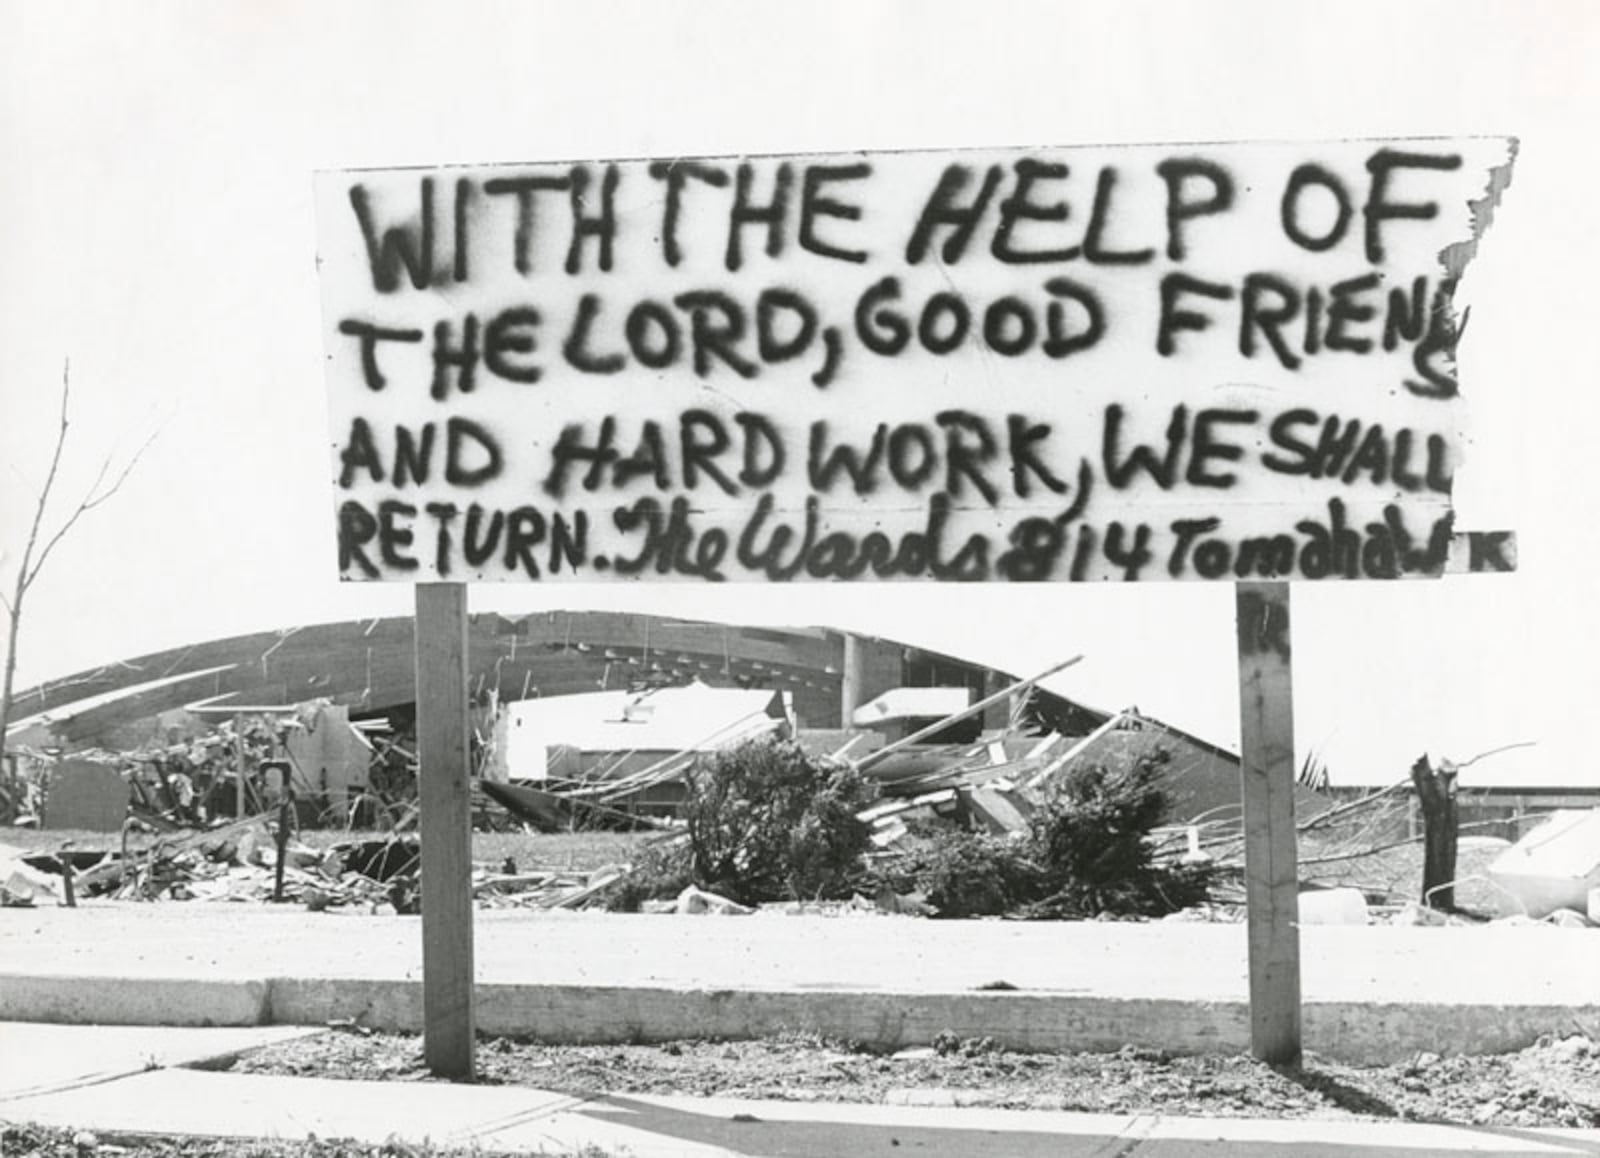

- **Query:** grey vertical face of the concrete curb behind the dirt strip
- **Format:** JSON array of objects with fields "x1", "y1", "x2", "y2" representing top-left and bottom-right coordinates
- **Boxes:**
[{"x1": 12, "y1": 976, "x2": 1600, "y2": 1064}]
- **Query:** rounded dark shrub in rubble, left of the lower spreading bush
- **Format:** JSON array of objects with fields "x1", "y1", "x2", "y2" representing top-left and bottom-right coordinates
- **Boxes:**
[{"x1": 683, "y1": 739, "x2": 870, "y2": 904}]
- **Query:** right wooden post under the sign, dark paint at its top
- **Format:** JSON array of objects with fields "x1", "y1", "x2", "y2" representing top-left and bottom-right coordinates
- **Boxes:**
[{"x1": 1235, "y1": 582, "x2": 1301, "y2": 1065}]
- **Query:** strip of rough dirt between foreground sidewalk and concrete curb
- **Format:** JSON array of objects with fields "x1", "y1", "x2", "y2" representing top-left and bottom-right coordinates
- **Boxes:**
[{"x1": 234, "y1": 1030, "x2": 1600, "y2": 1126}]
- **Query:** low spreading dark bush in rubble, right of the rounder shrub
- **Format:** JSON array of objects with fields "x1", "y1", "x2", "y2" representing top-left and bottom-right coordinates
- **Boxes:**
[{"x1": 878, "y1": 750, "x2": 1213, "y2": 918}]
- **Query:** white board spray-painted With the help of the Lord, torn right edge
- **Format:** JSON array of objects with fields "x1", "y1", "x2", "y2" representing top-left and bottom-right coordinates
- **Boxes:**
[{"x1": 317, "y1": 139, "x2": 1514, "y2": 582}]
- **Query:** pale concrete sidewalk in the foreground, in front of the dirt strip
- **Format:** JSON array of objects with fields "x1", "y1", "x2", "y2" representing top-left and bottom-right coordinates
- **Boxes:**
[{"x1": 0, "y1": 1024, "x2": 1600, "y2": 1158}]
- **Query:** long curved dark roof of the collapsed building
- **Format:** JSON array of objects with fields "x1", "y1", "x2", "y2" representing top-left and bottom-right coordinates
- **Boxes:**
[{"x1": 13, "y1": 611, "x2": 1106, "y2": 747}]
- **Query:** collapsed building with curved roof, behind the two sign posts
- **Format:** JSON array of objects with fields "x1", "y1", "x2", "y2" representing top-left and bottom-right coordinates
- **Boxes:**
[{"x1": 8, "y1": 611, "x2": 1312, "y2": 827}]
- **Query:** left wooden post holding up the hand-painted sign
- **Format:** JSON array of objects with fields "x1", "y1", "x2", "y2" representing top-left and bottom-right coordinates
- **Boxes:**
[{"x1": 416, "y1": 582, "x2": 477, "y2": 1081}]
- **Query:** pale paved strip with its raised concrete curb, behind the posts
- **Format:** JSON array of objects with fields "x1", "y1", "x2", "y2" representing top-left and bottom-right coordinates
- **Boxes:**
[{"x1": 0, "y1": 902, "x2": 1600, "y2": 1062}]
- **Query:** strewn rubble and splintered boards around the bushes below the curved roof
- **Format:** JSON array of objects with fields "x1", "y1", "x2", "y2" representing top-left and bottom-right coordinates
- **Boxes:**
[{"x1": 0, "y1": 659, "x2": 1600, "y2": 926}]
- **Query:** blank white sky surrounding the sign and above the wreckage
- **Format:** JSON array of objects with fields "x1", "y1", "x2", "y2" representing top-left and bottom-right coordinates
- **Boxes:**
[{"x1": 0, "y1": 0, "x2": 1600, "y2": 782}]
